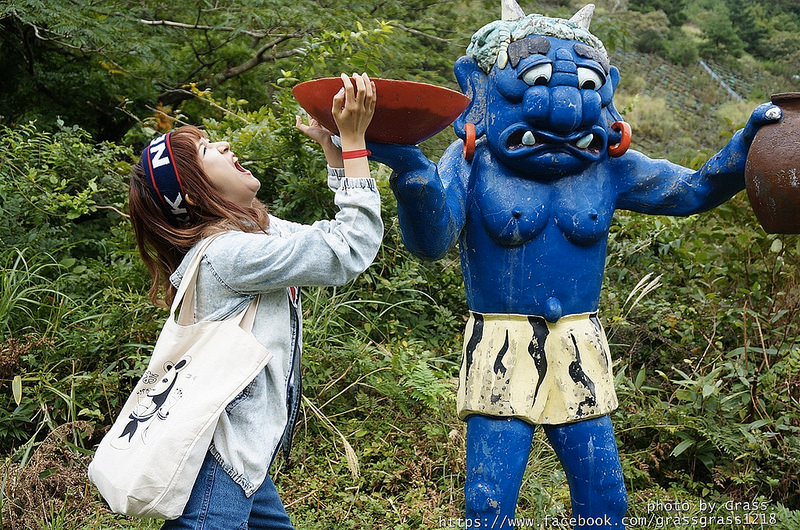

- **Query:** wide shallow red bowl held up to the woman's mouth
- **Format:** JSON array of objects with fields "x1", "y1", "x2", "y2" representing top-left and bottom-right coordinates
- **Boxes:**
[{"x1": 292, "y1": 77, "x2": 470, "y2": 145}]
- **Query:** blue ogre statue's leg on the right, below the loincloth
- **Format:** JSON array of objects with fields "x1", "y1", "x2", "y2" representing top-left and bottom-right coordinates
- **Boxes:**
[{"x1": 545, "y1": 416, "x2": 628, "y2": 530}]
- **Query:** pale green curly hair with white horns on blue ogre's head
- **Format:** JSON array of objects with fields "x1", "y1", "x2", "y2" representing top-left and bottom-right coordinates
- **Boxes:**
[{"x1": 467, "y1": 0, "x2": 608, "y2": 73}]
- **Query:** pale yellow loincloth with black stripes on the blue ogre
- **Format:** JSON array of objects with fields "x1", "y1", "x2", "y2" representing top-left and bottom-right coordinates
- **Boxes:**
[{"x1": 458, "y1": 313, "x2": 617, "y2": 425}]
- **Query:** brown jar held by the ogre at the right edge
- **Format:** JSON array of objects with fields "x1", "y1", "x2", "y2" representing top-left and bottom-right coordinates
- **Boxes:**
[{"x1": 744, "y1": 92, "x2": 800, "y2": 234}]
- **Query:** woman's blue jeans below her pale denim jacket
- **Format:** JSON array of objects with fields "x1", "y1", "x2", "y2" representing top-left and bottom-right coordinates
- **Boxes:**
[{"x1": 161, "y1": 453, "x2": 293, "y2": 530}]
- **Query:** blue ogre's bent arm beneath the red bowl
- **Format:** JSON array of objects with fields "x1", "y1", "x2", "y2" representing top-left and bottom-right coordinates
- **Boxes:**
[{"x1": 368, "y1": 141, "x2": 468, "y2": 260}]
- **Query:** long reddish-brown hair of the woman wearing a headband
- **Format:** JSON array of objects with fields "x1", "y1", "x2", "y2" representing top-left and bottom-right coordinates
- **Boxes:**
[{"x1": 129, "y1": 126, "x2": 269, "y2": 306}]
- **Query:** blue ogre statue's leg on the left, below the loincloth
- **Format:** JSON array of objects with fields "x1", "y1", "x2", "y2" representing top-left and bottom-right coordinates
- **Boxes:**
[{"x1": 464, "y1": 415, "x2": 534, "y2": 528}]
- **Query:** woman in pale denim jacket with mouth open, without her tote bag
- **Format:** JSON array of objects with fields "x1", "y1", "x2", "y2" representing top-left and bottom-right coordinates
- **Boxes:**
[{"x1": 130, "y1": 74, "x2": 383, "y2": 530}]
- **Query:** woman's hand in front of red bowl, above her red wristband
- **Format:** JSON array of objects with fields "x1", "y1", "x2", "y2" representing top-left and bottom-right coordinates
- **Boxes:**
[{"x1": 331, "y1": 74, "x2": 377, "y2": 150}]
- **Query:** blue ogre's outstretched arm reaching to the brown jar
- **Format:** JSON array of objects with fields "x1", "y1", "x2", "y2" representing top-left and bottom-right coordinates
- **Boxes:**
[{"x1": 610, "y1": 104, "x2": 780, "y2": 215}]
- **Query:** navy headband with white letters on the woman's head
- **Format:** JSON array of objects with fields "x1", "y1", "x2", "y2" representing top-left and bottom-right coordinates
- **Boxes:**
[{"x1": 142, "y1": 132, "x2": 190, "y2": 223}]
